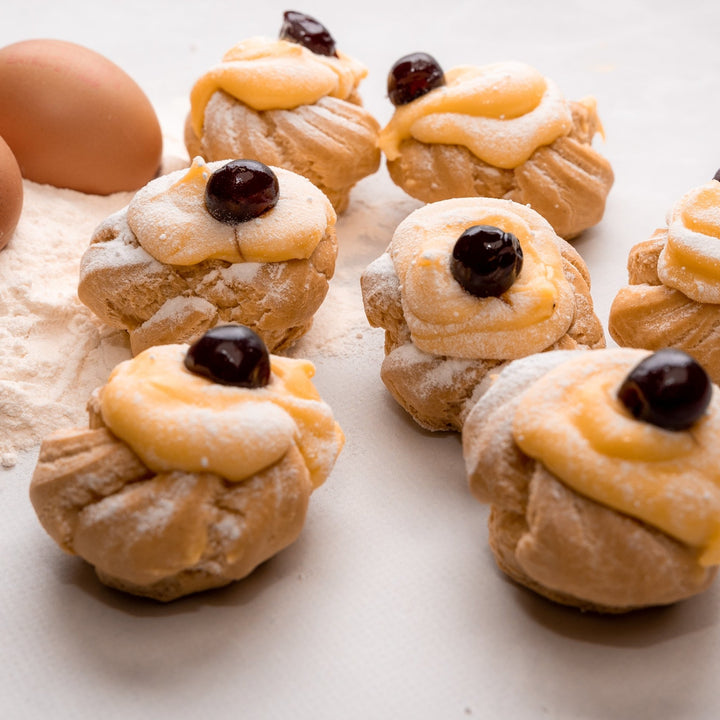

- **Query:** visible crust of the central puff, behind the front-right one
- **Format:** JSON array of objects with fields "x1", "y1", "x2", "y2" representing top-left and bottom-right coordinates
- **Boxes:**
[{"x1": 361, "y1": 201, "x2": 605, "y2": 431}]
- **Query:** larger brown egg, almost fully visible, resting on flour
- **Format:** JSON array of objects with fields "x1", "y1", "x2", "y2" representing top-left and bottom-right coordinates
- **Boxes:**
[{"x1": 0, "y1": 40, "x2": 162, "y2": 195}]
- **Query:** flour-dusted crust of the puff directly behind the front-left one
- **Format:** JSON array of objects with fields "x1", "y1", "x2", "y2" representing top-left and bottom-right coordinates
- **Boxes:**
[{"x1": 78, "y1": 167, "x2": 337, "y2": 354}]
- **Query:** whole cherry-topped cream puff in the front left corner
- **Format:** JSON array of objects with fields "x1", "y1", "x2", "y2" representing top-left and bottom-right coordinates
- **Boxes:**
[{"x1": 30, "y1": 325, "x2": 343, "y2": 601}]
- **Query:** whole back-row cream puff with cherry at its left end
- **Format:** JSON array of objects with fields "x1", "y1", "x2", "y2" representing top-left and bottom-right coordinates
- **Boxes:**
[{"x1": 379, "y1": 53, "x2": 613, "y2": 239}]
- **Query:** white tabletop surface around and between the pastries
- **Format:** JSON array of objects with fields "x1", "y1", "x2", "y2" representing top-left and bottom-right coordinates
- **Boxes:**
[{"x1": 0, "y1": 0, "x2": 720, "y2": 720}]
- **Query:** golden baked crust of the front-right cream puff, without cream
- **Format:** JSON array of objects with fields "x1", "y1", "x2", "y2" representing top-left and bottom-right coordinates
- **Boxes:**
[{"x1": 463, "y1": 352, "x2": 716, "y2": 613}]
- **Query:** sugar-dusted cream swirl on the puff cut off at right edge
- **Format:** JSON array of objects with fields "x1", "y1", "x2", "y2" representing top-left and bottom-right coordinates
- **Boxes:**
[{"x1": 657, "y1": 180, "x2": 720, "y2": 304}]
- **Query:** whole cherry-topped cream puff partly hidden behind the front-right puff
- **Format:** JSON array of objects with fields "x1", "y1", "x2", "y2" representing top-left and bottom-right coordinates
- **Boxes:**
[{"x1": 361, "y1": 198, "x2": 605, "y2": 430}]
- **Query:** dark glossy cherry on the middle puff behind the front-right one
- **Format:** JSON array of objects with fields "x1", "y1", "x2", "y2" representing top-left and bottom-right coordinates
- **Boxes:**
[{"x1": 450, "y1": 225, "x2": 523, "y2": 297}]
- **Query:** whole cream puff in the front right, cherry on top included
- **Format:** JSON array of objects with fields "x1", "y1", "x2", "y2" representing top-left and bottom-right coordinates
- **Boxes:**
[{"x1": 462, "y1": 348, "x2": 720, "y2": 613}]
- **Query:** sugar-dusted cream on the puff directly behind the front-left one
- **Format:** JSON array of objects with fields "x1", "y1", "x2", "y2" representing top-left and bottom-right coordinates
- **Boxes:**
[{"x1": 127, "y1": 158, "x2": 335, "y2": 265}]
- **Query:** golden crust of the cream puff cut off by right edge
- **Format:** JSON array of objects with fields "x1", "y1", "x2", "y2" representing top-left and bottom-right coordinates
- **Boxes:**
[{"x1": 608, "y1": 228, "x2": 720, "y2": 383}]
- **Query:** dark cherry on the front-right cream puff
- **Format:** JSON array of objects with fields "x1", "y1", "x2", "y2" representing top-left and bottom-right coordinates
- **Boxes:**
[{"x1": 618, "y1": 348, "x2": 712, "y2": 430}]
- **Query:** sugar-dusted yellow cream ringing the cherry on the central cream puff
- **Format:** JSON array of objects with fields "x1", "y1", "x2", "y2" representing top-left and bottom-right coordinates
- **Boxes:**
[{"x1": 388, "y1": 198, "x2": 575, "y2": 360}]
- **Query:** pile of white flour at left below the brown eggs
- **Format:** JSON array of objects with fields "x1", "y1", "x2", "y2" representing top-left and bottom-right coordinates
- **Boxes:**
[{"x1": 0, "y1": 181, "x2": 132, "y2": 467}]
